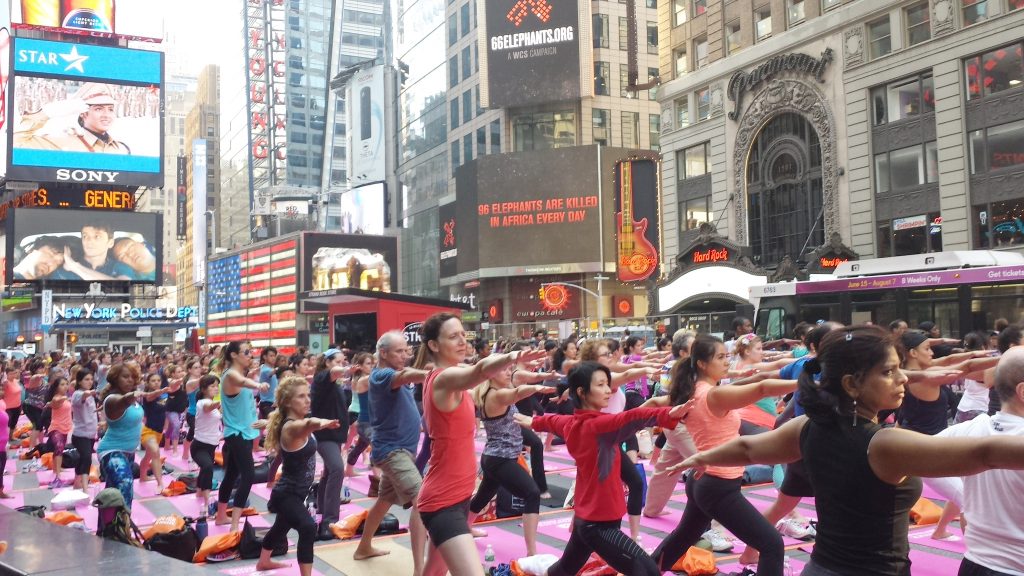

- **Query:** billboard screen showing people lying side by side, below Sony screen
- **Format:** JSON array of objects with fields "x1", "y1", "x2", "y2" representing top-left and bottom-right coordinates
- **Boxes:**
[{"x1": 7, "y1": 208, "x2": 163, "y2": 283}]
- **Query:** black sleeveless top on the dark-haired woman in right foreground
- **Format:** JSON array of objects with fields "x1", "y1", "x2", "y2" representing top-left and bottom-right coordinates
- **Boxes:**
[{"x1": 800, "y1": 417, "x2": 922, "y2": 576}]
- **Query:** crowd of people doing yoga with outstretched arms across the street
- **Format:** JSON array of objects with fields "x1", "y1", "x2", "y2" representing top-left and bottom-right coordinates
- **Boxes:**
[{"x1": 0, "y1": 314, "x2": 1024, "y2": 576}]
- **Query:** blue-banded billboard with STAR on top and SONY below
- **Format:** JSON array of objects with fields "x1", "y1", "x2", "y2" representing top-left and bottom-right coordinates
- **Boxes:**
[{"x1": 7, "y1": 38, "x2": 164, "y2": 187}]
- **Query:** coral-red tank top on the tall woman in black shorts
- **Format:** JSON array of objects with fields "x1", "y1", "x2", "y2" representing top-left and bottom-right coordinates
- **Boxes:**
[{"x1": 419, "y1": 370, "x2": 476, "y2": 512}]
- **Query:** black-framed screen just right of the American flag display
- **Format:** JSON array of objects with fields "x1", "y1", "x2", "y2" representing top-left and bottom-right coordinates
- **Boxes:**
[{"x1": 302, "y1": 233, "x2": 398, "y2": 292}]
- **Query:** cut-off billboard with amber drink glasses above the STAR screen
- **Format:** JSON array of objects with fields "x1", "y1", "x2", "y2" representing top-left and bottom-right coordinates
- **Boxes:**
[{"x1": 11, "y1": 0, "x2": 164, "y2": 39}]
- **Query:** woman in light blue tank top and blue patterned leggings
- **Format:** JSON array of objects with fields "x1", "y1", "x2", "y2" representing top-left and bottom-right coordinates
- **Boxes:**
[{"x1": 96, "y1": 364, "x2": 142, "y2": 507}]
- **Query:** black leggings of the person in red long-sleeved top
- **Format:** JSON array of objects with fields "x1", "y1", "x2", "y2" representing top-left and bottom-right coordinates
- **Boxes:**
[{"x1": 548, "y1": 517, "x2": 662, "y2": 576}]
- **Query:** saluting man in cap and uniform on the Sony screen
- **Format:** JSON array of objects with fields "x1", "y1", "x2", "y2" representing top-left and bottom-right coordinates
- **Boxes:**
[{"x1": 14, "y1": 82, "x2": 131, "y2": 154}]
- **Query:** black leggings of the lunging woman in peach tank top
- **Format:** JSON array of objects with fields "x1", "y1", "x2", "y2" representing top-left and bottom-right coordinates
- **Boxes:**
[{"x1": 654, "y1": 474, "x2": 785, "y2": 576}]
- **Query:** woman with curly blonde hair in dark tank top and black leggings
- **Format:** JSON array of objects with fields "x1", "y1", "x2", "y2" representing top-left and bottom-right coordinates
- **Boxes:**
[{"x1": 256, "y1": 376, "x2": 341, "y2": 576}]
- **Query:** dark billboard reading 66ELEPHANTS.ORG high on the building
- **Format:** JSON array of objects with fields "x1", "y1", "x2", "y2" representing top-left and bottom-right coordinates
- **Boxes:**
[{"x1": 476, "y1": 0, "x2": 594, "y2": 108}]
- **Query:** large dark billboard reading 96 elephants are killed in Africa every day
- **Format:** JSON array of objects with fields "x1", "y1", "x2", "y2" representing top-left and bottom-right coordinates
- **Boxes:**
[{"x1": 456, "y1": 147, "x2": 607, "y2": 276}]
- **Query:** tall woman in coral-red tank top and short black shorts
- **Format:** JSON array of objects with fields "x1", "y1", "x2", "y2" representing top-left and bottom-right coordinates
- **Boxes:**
[{"x1": 414, "y1": 313, "x2": 545, "y2": 576}]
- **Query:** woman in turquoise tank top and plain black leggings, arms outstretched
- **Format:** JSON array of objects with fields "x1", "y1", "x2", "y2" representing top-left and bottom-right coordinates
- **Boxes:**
[{"x1": 214, "y1": 340, "x2": 269, "y2": 532}]
